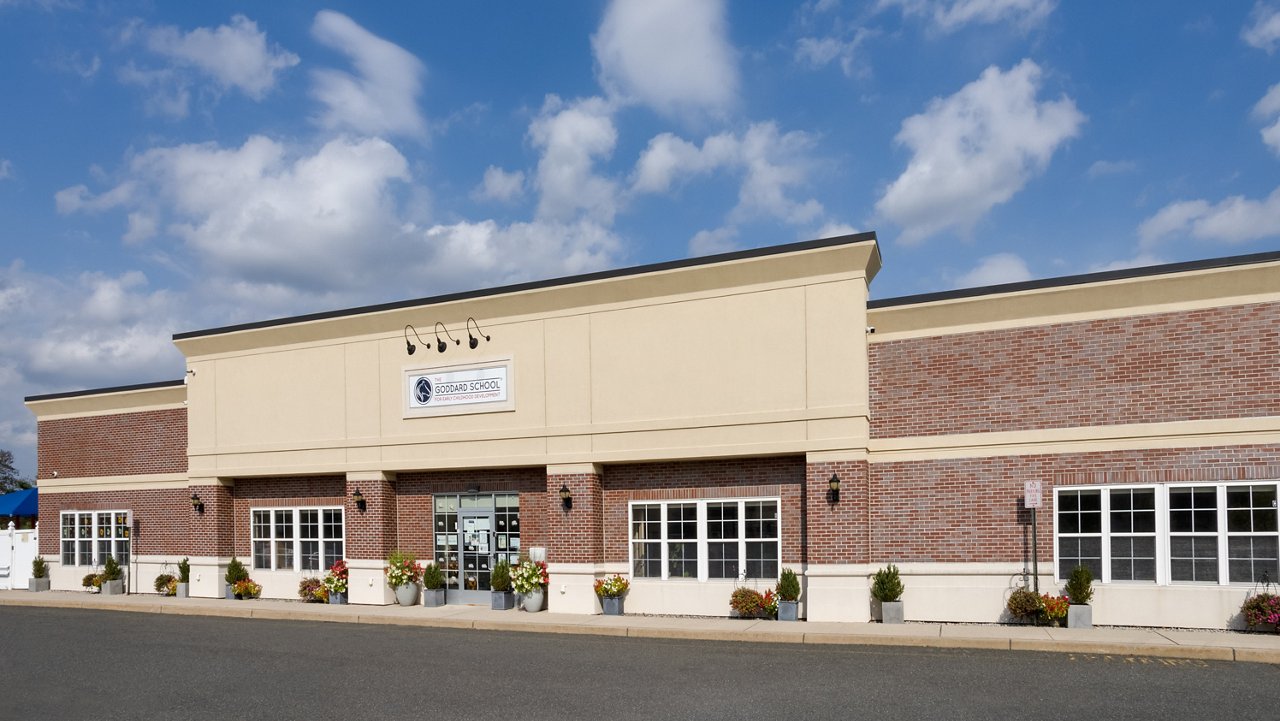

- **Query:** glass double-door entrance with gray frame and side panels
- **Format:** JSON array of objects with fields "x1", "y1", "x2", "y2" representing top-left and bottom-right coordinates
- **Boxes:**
[{"x1": 433, "y1": 493, "x2": 520, "y2": 606}]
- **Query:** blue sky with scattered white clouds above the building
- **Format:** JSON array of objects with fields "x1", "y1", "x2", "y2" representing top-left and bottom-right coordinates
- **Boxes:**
[{"x1": 0, "y1": 0, "x2": 1280, "y2": 475}]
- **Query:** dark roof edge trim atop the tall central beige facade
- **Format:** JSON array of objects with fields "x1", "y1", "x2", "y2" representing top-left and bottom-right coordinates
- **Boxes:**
[{"x1": 173, "y1": 231, "x2": 876, "y2": 341}]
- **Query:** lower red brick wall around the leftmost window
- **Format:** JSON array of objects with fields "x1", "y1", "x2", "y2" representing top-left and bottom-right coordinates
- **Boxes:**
[{"x1": 40, "y1": 488, "x2": 195, "y2": 557}]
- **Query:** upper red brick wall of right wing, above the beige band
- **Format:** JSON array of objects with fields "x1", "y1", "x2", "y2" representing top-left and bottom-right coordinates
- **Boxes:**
[{"x1": 869, "y1": 304, "x2": 1280, "y2": 438}]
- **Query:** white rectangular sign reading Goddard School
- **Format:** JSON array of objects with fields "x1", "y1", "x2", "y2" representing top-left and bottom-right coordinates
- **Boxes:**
[{"x1": 404, "y1": 362, "x2": 512, "y2": 416}]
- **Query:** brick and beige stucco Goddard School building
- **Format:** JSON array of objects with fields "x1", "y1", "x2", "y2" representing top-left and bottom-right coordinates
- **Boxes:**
[{"x1": 27, "y1": 233, "x2": 1280, "y2": 628}]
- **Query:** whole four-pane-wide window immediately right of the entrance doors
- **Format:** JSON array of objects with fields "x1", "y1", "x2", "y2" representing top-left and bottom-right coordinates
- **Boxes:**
[{"x1": 631, "y1": 499, "x2": 781, "y2": 580}]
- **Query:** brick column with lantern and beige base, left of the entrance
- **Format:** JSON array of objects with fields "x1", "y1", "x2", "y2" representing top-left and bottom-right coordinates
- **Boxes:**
[{"x1": 342, "y1": 471, "x2": 398, "y2": 606}]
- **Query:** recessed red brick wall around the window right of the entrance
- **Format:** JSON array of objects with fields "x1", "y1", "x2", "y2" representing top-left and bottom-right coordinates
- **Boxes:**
[{"x1": 599, "y1": 456, "x2": 805, "y2": 563}]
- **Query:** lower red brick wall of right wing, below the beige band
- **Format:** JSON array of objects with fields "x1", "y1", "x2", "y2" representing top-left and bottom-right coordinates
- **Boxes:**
[{"x1": 869, "y1": 444, "x2": 1280, "y2": 562}]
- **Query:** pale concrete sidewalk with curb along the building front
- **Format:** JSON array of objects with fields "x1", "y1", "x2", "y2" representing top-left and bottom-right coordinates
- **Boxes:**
[{"x1": 0, "y1": 590, "x2": 1280, "y2": 663}]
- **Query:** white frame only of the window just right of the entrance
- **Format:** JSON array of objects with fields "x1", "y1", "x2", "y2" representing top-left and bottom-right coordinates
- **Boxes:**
[{"x1": 627, "y1": 496, "x2": 782, "y2": 583}]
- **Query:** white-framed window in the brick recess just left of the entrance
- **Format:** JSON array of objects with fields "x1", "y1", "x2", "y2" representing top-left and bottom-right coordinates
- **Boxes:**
[{"x1": 250, "y1": 508, "x2": 343, "y2": 571}]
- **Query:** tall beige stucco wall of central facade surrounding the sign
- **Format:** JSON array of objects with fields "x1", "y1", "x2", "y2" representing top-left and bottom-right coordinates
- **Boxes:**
[{"x1": 177, "y1": 239, "x2": 879, "y2": 476}]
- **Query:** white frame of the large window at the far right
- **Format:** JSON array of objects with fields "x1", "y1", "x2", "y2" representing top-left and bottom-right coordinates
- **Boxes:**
[{"x1": 1052, "y1": 480, "x2": 1280, "y2": 587}]
